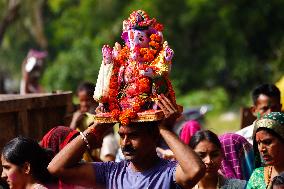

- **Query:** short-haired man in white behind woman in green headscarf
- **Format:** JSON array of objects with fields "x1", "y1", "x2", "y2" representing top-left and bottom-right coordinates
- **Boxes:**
[{"x1": 236, "y1": 84, "x2": 282, "y2": 144}]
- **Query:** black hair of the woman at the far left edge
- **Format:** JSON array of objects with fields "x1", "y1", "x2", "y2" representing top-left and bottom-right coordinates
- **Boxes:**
[{"x1": 2, "y1": 136, "x2": 54, "y2": 184}]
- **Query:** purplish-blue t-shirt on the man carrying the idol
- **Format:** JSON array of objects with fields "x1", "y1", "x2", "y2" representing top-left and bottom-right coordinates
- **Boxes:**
[{"x1": 93, "y1": 159, "x2": 181, "y2": 189}]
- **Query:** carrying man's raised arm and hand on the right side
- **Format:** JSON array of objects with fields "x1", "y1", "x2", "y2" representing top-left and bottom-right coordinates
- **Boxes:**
[{"x1": 158, "y1": 95, "x2": 205, "y2": 188}]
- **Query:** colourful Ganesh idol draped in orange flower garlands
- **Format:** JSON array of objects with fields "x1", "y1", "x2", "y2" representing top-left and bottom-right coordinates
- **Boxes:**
[{"x1": 94, "y1": 10, "x2": 176, "y2": 125}]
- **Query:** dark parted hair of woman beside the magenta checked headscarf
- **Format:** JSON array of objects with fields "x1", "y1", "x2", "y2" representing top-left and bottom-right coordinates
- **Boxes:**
[{"x1": 189, "y1": 130, "x2": 222, "y2": 150}]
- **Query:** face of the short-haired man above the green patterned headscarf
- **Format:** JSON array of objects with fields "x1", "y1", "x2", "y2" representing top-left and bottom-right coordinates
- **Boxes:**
[{"x1": 252, "y1": 94, "x2": 282, "y2": 117}]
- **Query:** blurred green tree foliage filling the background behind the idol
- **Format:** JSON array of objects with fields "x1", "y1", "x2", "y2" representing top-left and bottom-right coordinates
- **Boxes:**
[{"x1": 0, "y1": 0, "x2": 284, "y2": 102}]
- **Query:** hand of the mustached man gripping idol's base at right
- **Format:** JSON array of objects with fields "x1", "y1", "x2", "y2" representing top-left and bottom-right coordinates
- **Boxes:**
[{"x1": 157, "y1": 94, "x2": 180, "y2": 129}]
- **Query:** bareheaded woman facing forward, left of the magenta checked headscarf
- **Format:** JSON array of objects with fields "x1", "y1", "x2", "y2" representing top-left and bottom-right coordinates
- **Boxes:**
[{"x1": 189, "y1": 130, "x2": 246, "y2": 189}]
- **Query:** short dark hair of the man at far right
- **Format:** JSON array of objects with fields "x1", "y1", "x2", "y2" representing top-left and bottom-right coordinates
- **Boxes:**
[{"x1": 252, "y1": 83, "x2": 281, "y2": 105}]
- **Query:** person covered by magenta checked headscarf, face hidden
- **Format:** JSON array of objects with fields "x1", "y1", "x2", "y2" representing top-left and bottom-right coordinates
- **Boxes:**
[{"x1": 219, "y1": 133, "x2": 254, "y2": 181}]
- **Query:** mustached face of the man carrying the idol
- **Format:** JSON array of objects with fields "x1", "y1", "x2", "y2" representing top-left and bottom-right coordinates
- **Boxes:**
[{"x1": 118, "y1": 124, "x2": 157, "y2": 162}]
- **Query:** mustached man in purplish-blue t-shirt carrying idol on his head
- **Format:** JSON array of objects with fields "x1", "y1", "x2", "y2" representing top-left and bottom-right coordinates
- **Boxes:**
[{"x1": 48, "y1": 95, "x2": 205, "y2": 189}]
